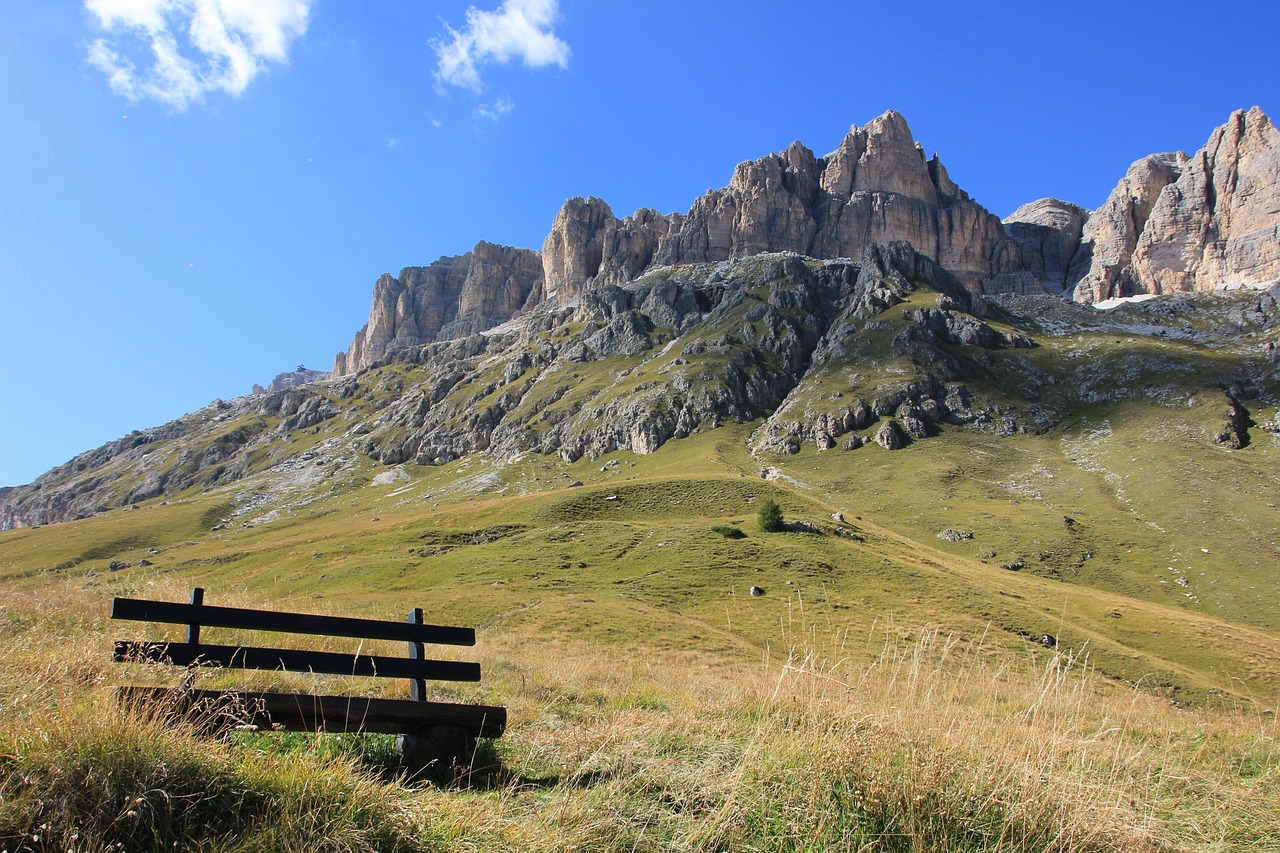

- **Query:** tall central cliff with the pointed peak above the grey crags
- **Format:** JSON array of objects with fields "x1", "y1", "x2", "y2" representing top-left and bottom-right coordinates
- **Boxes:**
[{"x1": 543, "y1": 111, "x2": 1029, "y2": 301}]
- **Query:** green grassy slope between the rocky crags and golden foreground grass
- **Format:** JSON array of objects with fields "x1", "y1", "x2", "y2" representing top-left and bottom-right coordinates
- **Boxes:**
[{"x1": 0, "y1": 412, "x2": 1280, "y2": 704}]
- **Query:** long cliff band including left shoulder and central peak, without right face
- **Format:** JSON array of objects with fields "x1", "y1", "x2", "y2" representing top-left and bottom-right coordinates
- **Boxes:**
[{"x1": 334, "y1": 111, "x2": 1059, "y2": 375}]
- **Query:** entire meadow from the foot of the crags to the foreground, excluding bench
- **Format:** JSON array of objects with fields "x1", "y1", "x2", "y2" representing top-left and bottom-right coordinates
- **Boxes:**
[{"x1": 0, "y1": 422, "x2": 1280, "y2": 852}]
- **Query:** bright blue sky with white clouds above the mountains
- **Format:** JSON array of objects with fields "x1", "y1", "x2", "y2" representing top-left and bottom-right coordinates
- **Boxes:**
[{"x1": 0, "y1": 0, "x2": 1280, "y2": 484}]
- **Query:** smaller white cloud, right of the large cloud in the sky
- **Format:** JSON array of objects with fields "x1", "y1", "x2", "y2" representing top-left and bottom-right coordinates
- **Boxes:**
[{"x1": 431, "y1": 0, "x2": 570, "y2": 92}]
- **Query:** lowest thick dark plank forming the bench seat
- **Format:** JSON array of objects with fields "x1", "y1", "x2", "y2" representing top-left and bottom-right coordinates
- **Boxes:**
[{"x1": 116, "y1": 686, "x2": 507, "y2": 738}]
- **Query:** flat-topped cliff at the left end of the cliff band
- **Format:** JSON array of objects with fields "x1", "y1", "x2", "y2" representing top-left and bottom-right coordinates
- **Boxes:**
[{"x1": 333, "y1": 242, "x2": 543, "y2": 377}]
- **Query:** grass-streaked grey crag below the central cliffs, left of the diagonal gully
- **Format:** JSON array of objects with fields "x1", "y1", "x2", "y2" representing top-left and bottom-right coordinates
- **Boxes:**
[{"x1": 355, "y1": 254, "x2": 858, "y2": 464}]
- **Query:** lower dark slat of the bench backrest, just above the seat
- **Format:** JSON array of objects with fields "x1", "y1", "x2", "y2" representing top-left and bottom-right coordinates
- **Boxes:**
[{"x1": 114, "y1": 640, "x2": 480, "y2": 681}]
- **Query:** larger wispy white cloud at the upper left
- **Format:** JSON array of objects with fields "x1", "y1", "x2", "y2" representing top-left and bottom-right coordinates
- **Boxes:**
[{"x1": 84, "y1": 0, "x2": 315, "y2": 110}]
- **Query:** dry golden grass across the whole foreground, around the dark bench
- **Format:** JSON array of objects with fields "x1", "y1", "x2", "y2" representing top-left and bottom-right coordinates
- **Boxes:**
[{"x1": 0, "y1": 573, "x2": 1280, "y2": 853}]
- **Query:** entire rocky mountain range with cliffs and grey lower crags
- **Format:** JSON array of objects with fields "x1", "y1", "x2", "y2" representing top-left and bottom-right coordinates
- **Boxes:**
[{"x1": 0, "y1": 108, "x2": 1280, "y2": 529}]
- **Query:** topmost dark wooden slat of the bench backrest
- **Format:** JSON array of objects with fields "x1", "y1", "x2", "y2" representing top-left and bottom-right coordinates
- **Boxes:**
[{"x1": 111, "y1": 598, "x2": 476, "y2": 646}]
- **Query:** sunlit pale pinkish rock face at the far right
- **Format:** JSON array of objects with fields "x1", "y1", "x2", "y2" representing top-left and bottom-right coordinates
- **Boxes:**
[{"x1": 1071, "y1": 108, "x2": 1280, "y2": 302}]
